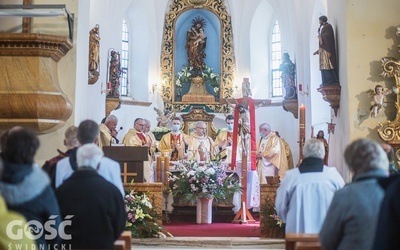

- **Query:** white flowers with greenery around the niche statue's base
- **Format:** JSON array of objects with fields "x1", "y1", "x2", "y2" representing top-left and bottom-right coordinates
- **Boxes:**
[{"x1": 175, "y1": 65, "x2": 220, "y2": 95}]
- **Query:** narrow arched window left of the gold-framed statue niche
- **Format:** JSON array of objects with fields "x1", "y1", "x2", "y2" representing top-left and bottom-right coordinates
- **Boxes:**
[{"x1": 121, "y1": 19, "x2": 129, "y2": 96}]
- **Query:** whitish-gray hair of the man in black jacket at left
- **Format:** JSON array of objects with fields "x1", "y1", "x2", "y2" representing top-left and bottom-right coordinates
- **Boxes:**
[{"x1": 76, "y1": 143, "x2": 104, "y2": 169}]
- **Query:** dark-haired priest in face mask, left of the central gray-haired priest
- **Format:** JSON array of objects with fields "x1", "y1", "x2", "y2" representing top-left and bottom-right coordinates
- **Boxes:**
[{"x1": 158, "y1": 117, "x2": 190, "y2": 161}]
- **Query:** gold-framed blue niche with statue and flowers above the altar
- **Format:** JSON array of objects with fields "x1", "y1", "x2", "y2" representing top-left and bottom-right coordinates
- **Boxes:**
[{"x1": 161, "y1": 0, "x2": 234, "y2": 112}]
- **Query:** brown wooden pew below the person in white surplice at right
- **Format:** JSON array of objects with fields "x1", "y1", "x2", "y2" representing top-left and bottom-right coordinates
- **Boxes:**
[{"x1": 285, "y1": 233, "x2": 322, "y2": 250}]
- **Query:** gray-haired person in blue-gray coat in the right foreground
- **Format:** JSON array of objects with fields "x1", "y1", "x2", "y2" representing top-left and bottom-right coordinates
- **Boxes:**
[{"x1": 319, "y1": 138, "x2": 389, "y2": 250}]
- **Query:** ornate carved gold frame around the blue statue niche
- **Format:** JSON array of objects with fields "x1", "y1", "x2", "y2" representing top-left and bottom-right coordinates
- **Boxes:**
[{"x1": 161, "y1": 0, "x2": 235, "y2": 113}]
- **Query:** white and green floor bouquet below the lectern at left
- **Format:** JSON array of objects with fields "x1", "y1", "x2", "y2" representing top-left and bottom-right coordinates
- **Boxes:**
[{"x1": 125, "y1": 190, "x2": 163, "y2": 238}]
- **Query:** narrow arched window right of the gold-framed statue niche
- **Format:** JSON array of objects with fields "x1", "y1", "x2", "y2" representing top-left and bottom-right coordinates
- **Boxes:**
[{"x1": 271, "y1": 20, "x2": 283, "y2": 98}]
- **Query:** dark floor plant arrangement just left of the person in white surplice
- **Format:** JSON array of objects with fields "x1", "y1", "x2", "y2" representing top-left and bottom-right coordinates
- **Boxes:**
[{"x1": 260, "y1": 197, "x2": 285, "y2": 237}]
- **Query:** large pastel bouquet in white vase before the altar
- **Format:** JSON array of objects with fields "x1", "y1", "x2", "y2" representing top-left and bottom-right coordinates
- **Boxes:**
[{"x1": 170, "y1": 161, "x2": 240, "y2": 204}]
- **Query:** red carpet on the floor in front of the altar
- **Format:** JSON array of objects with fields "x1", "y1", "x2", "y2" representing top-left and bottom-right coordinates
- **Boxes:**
[{"x1": 163, "y1": 221, "x2": 260, "y2": 237}]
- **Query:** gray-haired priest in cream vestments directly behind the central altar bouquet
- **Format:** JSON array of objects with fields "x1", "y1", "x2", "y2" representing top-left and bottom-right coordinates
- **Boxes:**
[{"x1": 188, "y1": 121, "x2": 217, "y2": 161}]
